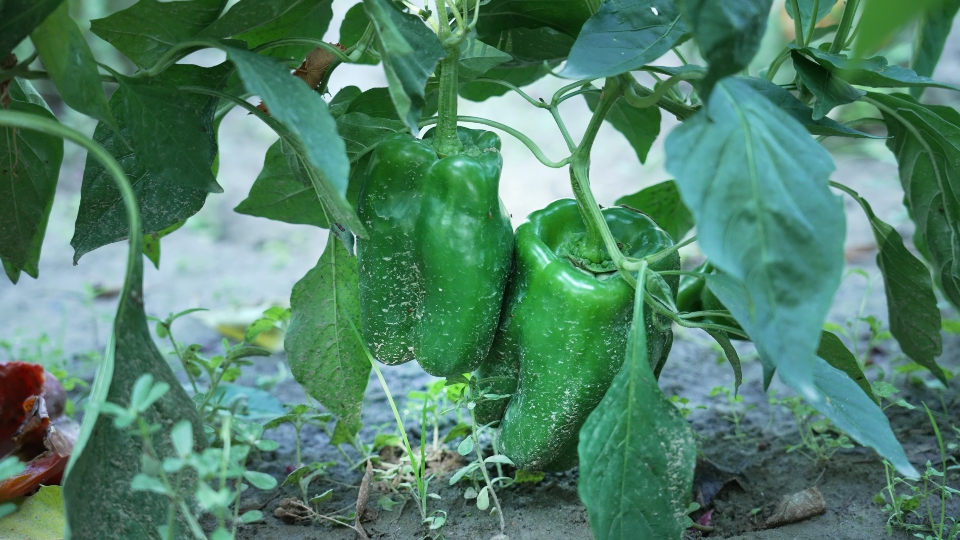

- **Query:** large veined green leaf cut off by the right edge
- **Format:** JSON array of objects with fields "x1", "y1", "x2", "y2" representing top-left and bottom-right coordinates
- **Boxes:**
[{"x1": 868, "y1": 93, "x2": 960, "y2": 312}]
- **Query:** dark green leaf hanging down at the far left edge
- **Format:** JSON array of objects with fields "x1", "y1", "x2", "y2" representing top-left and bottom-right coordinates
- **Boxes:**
[{"x1": 0, "y1": 79, "x2": 63, "y2": 283}]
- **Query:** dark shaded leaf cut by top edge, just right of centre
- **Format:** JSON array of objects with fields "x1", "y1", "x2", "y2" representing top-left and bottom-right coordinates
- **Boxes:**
[{"x1": 477, "y1": 0, "x2": 602, "y2": 38}]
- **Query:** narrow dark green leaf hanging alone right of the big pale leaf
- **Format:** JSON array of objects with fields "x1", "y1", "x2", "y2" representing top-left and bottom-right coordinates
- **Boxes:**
[{"x1": 834, "y1": 184, "x2": 947, "y2": 384}]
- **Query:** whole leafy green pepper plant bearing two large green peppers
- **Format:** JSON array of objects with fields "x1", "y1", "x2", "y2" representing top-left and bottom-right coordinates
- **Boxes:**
[{"x1": 0, "y1": 0, "x2": 960, "y2": 539}]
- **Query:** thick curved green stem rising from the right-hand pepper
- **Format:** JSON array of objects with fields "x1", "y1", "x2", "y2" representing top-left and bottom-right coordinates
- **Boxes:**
[{"x1": 570, "y1": 77, "x2": 622, "y2": 264}]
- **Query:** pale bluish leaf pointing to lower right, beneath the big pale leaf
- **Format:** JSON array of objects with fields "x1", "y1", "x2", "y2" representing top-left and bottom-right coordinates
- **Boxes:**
[{"x1": 705, "y1": 274, "x2": 917, "y2": 478}]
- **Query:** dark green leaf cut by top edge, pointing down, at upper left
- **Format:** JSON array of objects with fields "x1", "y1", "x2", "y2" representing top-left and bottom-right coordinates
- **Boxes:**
[{"x1": 90, "y1": 0, "x2": 227, "y2": 69}]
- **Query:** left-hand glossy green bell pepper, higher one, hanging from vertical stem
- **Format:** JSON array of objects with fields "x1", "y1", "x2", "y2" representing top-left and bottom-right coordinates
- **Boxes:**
[{"x1": 357, "y1": 128, "x2": 513, "y2": 377}]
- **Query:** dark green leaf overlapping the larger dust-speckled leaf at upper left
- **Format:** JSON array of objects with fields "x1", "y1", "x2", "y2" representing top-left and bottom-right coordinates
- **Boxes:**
[{"x1": 116, "y1": 75, "x2": 223, "y2": 193}]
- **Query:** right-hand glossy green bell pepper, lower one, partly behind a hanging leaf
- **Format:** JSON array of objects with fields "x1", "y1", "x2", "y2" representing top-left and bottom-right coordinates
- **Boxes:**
[{"x1": 475, "y1": 199, "x2": 680, "y2": 471}]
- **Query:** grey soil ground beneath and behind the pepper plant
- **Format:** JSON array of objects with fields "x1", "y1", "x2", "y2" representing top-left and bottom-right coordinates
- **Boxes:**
[{"x1": 0, "y1": 0, "x2": 960, "y2": 540}]
